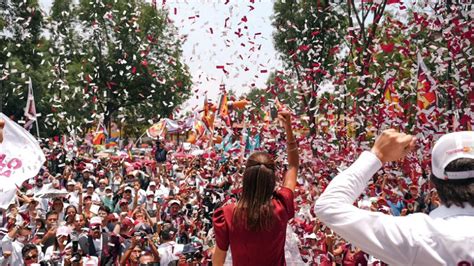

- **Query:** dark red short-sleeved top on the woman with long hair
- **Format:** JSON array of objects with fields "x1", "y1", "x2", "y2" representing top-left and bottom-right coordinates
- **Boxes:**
[{"x1": 213, "y1": 187, "x2": 295, "y2": 266}]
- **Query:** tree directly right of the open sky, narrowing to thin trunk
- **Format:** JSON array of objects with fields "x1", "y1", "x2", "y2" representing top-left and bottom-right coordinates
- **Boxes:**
[{"x1": 273, "y1": 1, "x2": 348, "y2": 153}]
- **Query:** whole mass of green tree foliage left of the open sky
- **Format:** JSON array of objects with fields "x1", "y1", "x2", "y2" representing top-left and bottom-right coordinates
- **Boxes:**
[{"x1": 0, "y1": 0, "x2": 191, "y2": 136}]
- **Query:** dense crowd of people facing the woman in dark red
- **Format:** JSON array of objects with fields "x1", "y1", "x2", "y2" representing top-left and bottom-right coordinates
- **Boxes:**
[{"x1": 0, "y1": 119, "x2": 448, "y2": 265}]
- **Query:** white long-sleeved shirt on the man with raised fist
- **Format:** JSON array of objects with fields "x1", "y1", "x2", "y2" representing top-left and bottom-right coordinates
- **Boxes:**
[{"x1": 314, "y1": 152, "x2": 474, "y2": 265}]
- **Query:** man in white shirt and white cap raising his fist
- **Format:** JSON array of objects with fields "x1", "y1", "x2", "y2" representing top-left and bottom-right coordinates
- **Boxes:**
[{"x1": 314, "y1": 129, "x2": 474, "y2": 265}]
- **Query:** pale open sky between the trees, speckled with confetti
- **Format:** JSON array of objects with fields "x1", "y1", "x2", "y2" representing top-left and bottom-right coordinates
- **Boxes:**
[{"x1": 40, "y1": 0, "x2": 281, "y2": 110}]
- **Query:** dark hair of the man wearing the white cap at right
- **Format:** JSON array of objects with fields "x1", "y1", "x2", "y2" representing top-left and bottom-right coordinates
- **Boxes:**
[{"x1": 430, "y1": 158, "x2": 474, "y2": 208}]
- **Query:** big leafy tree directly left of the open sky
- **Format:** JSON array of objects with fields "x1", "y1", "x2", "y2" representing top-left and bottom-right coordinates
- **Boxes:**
[{"x1": 75, "y1": 0, "x2": 191, "y2": 135}]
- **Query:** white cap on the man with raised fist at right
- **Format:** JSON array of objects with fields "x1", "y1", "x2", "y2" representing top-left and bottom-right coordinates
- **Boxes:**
[{"x1": 431, "y1": 131, "x2": 474, "y2": 180}]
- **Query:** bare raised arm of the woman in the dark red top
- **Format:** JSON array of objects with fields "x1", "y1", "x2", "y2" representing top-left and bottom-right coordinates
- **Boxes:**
[{"x1": 278, "y1": 111, "x2": 299, "y2": 191}]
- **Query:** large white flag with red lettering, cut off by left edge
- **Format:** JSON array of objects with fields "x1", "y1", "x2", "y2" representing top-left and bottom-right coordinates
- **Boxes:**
[{"x1": 0, "y1": 113, "x2": 46, "y2": 190}]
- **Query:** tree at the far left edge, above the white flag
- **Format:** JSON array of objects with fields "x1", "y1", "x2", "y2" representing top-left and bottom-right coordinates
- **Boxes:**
[{"x1": 0, "y1": 0, "x2": 48, "y2": 128}]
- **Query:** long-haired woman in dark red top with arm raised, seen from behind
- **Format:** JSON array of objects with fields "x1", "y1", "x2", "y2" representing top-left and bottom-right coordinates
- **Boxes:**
[{"x1": 212, "y1": 111, "x2": 299, "y2": 266}]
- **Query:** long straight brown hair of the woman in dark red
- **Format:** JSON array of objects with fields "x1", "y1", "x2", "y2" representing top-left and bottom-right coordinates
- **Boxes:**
[{"x1": 233, "y1": 152, "x2": 276, "y2": 231}]
